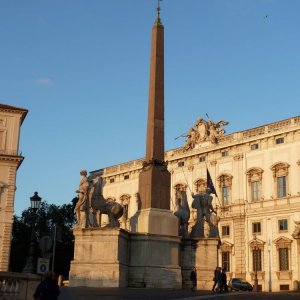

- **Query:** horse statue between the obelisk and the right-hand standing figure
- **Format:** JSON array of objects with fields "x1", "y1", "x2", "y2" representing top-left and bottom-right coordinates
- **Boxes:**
[{"x1": 174, "y1": 191, "x2": 190, "y2": 238}]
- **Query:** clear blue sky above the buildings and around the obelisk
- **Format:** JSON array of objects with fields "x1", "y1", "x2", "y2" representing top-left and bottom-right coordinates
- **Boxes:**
[{"x1": 0, "y1": 0, "x2": 300, "y2": 215}]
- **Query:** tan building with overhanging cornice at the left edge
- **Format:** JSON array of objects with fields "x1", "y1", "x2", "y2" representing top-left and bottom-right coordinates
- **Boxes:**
[{"x1": 0, "y1": 104, "x2": 28, "y2": 272}]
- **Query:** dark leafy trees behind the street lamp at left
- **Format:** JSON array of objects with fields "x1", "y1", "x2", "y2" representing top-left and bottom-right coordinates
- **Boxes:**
[{"x1": 10, "y1": 198, "x2": 76, "y2": 277}]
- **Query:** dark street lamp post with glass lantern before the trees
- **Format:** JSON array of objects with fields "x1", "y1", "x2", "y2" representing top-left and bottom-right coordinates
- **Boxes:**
[{"x1": 22, "y1": 192, "x2": 42, "y2": 273}]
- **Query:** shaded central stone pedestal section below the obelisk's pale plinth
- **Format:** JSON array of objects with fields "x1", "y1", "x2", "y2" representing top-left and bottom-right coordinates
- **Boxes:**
[{"x1": 128, "y1": 233, "x2": 182, "y2": 289}]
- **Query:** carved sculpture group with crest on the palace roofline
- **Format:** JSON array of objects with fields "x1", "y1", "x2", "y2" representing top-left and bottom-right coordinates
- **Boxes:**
[{"x1": 179, "y1": 118, "x2": 229, "y2": 151}]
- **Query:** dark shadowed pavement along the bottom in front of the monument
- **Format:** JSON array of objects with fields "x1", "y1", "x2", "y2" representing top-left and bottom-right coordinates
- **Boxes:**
[{"x1": 59, "y1": 287, "x2": 300, "y2": 300}]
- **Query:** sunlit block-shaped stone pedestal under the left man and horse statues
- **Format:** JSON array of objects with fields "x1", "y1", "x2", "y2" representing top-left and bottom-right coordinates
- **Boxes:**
[{"x1": 69, "y1": 228, "x2": 128, "y2": 287}]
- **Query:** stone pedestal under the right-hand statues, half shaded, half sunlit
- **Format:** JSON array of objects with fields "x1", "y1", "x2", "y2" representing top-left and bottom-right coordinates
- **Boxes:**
[{"x1": 180, "y1": 238, "x2": 219, "y2": 290}]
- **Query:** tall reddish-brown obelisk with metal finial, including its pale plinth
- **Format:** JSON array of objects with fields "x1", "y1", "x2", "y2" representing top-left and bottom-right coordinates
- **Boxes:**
[{"x1": 138, "y1": 0, "x2": 177, "y2": 235}]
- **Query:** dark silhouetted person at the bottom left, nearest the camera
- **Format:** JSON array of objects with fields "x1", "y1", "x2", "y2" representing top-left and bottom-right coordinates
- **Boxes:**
[{"x1": 33, "y1": 272, "x2": 60, "y2": 300}]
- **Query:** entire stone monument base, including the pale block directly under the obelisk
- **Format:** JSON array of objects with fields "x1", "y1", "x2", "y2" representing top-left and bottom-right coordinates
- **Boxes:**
[{"x1": 69, "y1": 216, "x2": 218, "y2": 290}]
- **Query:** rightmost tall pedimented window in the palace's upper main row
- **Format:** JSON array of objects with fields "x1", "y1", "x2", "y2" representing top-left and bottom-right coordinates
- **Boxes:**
[{"x1": 271, "y1": 162, "x2": 290, "y2": 198}]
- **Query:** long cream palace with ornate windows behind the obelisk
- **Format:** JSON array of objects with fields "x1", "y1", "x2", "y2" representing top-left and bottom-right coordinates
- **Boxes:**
[{"x1": 90, "y1": 117, "x2": 300, "y2": 291}]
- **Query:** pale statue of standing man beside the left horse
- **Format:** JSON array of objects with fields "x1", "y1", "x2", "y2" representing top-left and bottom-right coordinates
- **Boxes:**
[{"x1": 74, "y1": 170, "x2": 89, "y2": 228}]
